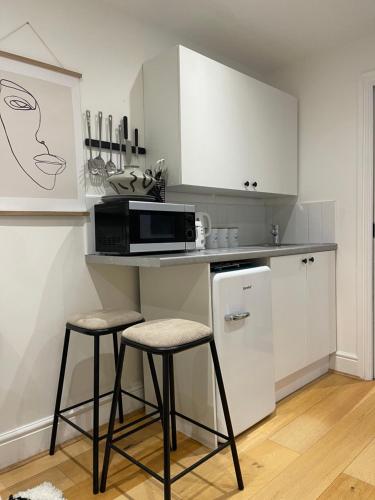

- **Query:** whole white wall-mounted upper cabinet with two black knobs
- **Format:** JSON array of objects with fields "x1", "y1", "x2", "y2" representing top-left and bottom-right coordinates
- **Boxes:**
[{"x1": 143, "y1": 46, "x2": 297, "y2": 195}]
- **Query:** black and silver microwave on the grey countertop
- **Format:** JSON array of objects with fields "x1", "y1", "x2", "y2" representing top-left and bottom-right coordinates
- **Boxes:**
[{"x1": 94, "y1": 199, "x2": 195, "y2": 255}]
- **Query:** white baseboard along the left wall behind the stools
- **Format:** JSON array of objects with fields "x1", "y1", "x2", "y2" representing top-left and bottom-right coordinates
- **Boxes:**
[{"x1": 0, "y1": 385, "x2": 143, "y2": 470}]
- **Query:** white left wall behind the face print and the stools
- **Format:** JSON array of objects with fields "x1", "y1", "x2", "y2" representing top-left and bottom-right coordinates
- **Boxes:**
[{"x1": 0, "y1": 0, "x2": 178, "y2": 468}]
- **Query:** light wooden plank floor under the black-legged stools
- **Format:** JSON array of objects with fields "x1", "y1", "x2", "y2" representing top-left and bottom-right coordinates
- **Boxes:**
[{"x1": 0, "y1": 373, "x2": 375, "y2": 500}]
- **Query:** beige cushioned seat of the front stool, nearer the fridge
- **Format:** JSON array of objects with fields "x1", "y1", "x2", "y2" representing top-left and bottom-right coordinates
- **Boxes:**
[{"x1": 122, "y1": 318, "x2": 212, "y2": 348}]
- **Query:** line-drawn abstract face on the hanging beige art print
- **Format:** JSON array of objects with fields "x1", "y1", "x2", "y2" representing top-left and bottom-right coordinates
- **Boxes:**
[{"x1": 0, "y1": 79, "x2": 66, "y2": 191}]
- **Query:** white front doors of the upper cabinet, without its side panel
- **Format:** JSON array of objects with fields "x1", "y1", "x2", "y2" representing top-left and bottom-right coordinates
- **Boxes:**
[{"x1": 179, "y1": 47, "x2": 297, "y2": 195}]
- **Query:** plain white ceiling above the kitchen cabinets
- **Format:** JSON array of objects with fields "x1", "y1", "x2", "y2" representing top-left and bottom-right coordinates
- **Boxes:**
[{"x1": 107, "y1": 0, "x2": 375, "y2": 73}]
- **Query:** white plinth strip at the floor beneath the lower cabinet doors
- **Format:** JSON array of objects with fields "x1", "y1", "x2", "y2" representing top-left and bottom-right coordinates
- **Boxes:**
[{"x1": 275, "y1": 356, "x2": 330, "y2": 401}]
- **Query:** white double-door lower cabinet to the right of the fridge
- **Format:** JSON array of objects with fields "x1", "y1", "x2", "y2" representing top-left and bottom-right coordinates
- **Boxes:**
[{"x1": 271, "y1": 251, "x2": 336, "y2": 382}]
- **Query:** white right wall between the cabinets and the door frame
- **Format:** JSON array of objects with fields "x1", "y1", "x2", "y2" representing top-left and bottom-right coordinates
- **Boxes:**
[{"x1": 268, "y1": 36, "x2": 375, "y2": 375}]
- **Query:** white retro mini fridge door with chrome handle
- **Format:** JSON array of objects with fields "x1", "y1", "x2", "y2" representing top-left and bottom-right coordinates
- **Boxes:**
[{"x1": 212, "y1": 266, "x2": 275, "y2": 435}]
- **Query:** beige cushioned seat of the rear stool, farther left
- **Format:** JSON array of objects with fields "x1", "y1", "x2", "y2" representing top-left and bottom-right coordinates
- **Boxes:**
[{"x1": 68, "y1": 309, "x2": 143, "y2": 330}]
